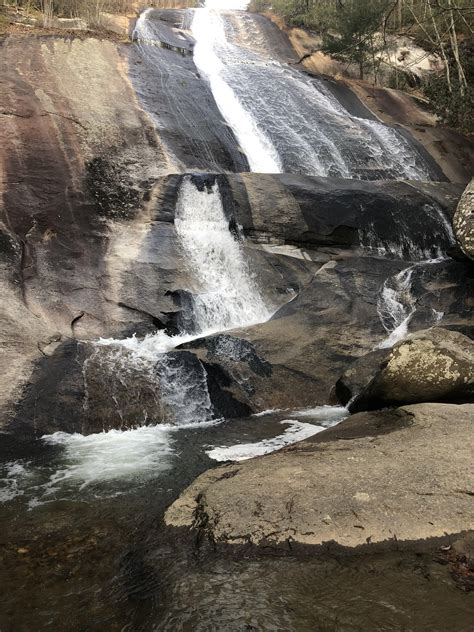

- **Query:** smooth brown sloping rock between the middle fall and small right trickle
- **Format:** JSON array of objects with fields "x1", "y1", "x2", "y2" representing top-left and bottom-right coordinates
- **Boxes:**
[{"x1": 184, "y1": 257, "x2": 472, "y2": 411}]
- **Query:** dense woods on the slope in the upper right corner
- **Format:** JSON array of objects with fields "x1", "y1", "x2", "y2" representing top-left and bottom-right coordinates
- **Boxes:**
[{"x1": 252, "y1": 0, "x2": 474, "y2": 132}]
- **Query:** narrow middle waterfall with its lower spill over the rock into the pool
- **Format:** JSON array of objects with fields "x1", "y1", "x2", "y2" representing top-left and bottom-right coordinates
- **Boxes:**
[{"x1": 91, "y1": 176, "x2": 272, "y2": 426}]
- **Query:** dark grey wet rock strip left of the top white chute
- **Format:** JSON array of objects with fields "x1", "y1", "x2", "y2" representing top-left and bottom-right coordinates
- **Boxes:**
[{"x1": 128, "y1": 10, "x2": 248, "y2": 173}]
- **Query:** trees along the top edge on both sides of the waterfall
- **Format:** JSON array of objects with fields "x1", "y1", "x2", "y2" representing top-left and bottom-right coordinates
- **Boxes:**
[{"x1": 4, "y1": 0, "x2": 474, "y2": 128}]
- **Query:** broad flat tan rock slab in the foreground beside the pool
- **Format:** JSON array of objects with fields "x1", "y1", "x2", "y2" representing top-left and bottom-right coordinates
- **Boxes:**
[{"x1": 165, "y1": 404, "x2": 474, "y2": 548}]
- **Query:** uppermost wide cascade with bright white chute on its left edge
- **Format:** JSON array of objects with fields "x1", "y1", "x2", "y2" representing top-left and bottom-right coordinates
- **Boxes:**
[{"x1": 191, "y1": 3, "x2": 430, "y2": 180}]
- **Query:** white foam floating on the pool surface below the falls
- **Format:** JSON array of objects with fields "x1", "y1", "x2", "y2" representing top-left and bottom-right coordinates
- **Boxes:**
[{"x1": 0, "y1": 406, "x2": 348, "y2": 509}]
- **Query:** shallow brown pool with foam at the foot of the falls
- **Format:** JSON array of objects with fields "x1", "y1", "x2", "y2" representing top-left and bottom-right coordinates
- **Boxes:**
[{"x1": 0, "y1": 407, "x2": 474, "y2": 632}]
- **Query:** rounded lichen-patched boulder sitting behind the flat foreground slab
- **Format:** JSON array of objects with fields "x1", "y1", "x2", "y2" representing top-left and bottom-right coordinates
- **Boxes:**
[{"x1": 336, "y1": 328, "x2": 474, "y2": 412}]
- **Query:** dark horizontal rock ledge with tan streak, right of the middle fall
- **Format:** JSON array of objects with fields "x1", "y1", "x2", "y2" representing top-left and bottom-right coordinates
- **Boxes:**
[{"x1": 156, "y1": 173, "x2": 463, "y2": 261}]
